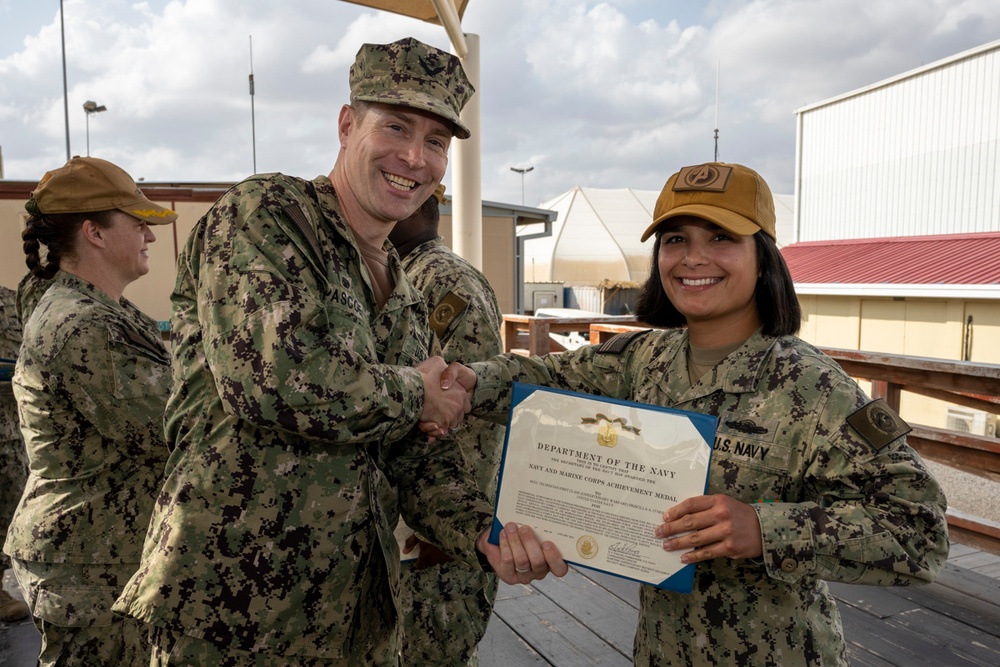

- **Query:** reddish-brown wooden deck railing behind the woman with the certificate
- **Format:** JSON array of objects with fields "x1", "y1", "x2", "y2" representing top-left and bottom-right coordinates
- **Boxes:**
[{"x1": 504, "y1": 315, "x2": 1000, "y2": 554}]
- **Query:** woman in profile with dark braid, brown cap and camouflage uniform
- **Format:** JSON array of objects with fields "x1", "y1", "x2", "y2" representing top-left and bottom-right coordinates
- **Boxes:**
[{"x1": 4, "y1": 157, "x2": 177, "y2": 667}]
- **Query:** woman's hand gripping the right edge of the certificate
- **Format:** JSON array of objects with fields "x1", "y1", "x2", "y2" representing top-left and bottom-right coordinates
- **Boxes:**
[{"x1": 655, "y1": 493, "x2": 764, "y2": 563}]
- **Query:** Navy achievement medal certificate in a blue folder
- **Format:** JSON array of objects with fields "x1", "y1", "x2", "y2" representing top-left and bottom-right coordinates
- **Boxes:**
[{"x1": 490, "y1": 382, "x2": 717, "y2": 593}]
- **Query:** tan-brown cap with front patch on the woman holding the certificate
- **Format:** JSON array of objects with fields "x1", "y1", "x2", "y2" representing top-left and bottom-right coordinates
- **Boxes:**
[{"x1": 640, "y1": 162, "x2": 777, "y2": 241}]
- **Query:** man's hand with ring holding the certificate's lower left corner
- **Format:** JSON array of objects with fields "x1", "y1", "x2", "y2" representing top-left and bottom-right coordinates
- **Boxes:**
[{"x1": 476, "y1": 522, "x2": 569, "y2": 584}]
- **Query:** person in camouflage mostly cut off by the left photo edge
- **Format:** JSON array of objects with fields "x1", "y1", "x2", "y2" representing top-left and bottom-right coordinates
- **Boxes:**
[{"x1": 0, "y1": 286, "x2": 31, "y2": 623}]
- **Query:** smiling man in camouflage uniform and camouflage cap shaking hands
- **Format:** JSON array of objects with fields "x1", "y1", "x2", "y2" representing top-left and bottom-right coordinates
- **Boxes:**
[{"x1": 115, "y1": 39, "x2": 564, "y2": 667}]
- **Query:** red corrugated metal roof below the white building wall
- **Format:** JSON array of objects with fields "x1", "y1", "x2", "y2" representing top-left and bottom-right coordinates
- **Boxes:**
[{"x1": 781, "y1": 232, "x2": 1000, "y2": 285}]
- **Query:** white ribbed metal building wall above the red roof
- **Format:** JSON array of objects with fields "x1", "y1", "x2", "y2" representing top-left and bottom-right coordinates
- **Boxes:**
[{"x1": 795, "y1": 40, "x2": 1000, "y2": 241}]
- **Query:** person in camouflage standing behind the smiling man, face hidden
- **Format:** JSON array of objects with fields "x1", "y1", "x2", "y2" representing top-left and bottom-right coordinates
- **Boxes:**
[{"x1": 389, "y1": 185, "x2": 504, "y2": 666}]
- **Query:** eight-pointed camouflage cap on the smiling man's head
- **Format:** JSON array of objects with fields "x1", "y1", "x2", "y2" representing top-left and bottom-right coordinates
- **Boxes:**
[{"x1": 350, "y1": 37, "x2": 476, "y2": 139}]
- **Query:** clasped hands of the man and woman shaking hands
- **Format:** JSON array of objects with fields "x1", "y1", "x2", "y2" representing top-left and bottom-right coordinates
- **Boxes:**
[{"x1": 416, "y1": 357, "x2": 476, "y2": 442}]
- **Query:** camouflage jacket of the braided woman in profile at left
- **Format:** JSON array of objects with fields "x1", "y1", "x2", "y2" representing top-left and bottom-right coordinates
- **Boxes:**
[{"x1": 4, "y1": 271, "x2": 170, "y2": 564}]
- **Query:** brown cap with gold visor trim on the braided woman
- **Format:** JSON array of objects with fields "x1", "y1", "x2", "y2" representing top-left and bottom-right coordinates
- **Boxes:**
[{"x1": 24, "y1": 156, "x2": 177, "y2": 225}]
